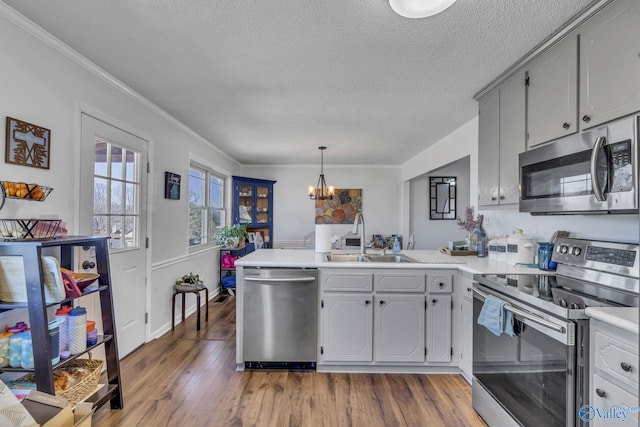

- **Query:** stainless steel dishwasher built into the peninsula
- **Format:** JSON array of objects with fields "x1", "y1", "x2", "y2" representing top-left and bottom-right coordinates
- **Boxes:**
[{"x1": 243, "y1": 268, "x2": 318, "y2": 369}]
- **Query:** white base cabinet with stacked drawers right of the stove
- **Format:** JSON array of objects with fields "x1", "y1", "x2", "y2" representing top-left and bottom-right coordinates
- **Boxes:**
[{"x1": 589, "y1": 319, "x2": 640, "y2": 426}]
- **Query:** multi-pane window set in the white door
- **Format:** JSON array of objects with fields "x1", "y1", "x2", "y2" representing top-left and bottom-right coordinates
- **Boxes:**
[{"x1": 93, "y1": 139, "x2": 140, "y2": 250}]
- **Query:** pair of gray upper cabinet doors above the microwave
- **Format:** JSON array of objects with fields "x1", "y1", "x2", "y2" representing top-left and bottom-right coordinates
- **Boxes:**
[{"x1": 525, "y1": 0, "x2": 640, "y2": 149}]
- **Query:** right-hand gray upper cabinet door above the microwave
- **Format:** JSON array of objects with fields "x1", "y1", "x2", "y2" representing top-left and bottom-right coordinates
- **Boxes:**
[{"x1": 578, "y1": 0, "x2": 640, "y2": 129}]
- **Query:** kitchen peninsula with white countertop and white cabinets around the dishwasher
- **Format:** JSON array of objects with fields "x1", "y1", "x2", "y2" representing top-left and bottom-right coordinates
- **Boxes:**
[{"x1": 236, "y1": 249, "x2": 539, "y2": 380}]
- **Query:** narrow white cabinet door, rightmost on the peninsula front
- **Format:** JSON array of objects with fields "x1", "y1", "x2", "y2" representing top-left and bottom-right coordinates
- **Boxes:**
[{"x1": 427, "y1": 294, "x2": 453, "y2": 362}]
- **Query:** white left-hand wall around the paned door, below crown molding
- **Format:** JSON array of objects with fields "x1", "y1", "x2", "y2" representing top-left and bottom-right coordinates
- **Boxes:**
[{"x1": 0, "y1": 2, "x2": 238, "y2": 342}]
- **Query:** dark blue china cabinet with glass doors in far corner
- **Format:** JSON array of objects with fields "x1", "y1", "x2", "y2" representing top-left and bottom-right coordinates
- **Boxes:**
[{"x1": 232, "y1": 176, "x2": 276, "y2": 248}]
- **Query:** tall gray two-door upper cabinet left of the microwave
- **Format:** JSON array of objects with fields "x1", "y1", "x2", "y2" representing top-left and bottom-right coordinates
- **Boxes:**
[{"x1": 478, "y1": 70, "x2": 526, "y2": 206}]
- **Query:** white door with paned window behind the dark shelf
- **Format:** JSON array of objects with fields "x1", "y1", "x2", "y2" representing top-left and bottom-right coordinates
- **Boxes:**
[{"x1": 79, "y1": 113, "x2": 148, "y2": 357}]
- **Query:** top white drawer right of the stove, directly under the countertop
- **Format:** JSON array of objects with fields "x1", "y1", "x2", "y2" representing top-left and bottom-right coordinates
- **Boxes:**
[{"x1": 594, "y1": 330, "x2": 639, "y2": 388}]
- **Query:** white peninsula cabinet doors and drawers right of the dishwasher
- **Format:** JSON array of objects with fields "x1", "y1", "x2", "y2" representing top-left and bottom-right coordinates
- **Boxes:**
[{"x1": 318, "y1": 269, "x2": 453, "y2": 366}]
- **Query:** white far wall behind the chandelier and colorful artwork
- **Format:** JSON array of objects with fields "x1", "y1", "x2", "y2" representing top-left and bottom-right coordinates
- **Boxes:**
[{"x1": 242, "y1": 165, "x2": 401, "y2": 247}]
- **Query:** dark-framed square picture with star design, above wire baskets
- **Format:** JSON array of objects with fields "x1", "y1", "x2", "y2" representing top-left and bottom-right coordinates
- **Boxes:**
[{"x1": 4, "y1": 117, "x2": 51, "y2": 169}]
